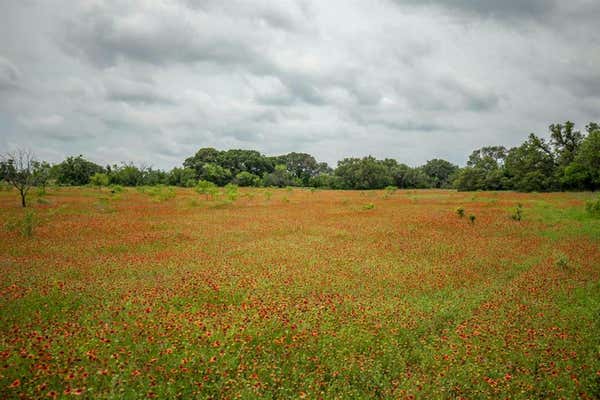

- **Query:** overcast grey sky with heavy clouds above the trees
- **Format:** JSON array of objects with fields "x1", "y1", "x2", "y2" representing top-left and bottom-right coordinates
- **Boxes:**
[{"x1": 0, "y1": 0, "x2": 600, "y2": 169}]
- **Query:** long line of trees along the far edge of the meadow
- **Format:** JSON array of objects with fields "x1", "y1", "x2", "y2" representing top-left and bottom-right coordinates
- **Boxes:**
[{"x1": 0, "y1": 121, "x2": 600, "y2": 206}]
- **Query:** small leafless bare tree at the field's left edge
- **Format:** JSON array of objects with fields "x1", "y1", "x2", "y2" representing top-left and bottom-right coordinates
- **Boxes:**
[{"x1": 0, "y1": 150, "x2": 40, "y2": 207}]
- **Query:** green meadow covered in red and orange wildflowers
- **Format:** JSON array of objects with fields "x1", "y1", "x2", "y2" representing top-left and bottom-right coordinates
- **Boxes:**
[{"x1": 0, "y1": 188, "x2": 600, "y2": 399}]
